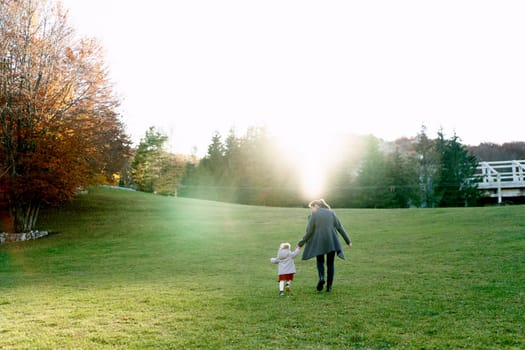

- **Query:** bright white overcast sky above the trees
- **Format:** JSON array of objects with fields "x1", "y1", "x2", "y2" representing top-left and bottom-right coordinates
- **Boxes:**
[{"x1": 62, "y1": 0, "x2": 525, "y2": 154}]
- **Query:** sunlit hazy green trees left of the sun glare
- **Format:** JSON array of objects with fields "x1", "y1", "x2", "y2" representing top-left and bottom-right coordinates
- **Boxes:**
[{"x1": 179, "y1": 128, "x2": 301, "y2": 206}]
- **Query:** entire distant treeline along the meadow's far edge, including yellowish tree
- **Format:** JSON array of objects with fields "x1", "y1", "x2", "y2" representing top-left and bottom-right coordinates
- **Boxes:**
[{"x1": 124, "y1": 127, "x2": 525, "y2": 208}]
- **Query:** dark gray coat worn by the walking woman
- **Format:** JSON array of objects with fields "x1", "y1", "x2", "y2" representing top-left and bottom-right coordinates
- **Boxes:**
[{"x1": 298, "y1": 208, "x2": 351, "y2": 260}]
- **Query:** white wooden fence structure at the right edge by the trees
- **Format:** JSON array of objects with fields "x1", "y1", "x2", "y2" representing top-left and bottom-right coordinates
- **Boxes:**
[{"x1": 477, "y1": 160, "x2": 525, "y2": 203}]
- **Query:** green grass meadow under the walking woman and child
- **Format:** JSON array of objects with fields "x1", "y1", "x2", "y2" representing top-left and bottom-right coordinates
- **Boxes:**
[{"x1": 0, "y1": 189, "x2": 525, "y2": 349}]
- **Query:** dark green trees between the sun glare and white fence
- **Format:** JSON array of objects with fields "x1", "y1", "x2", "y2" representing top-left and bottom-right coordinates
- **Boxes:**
[{"x1": 328, "y1": 130, "x2": 478, "y2": 208}]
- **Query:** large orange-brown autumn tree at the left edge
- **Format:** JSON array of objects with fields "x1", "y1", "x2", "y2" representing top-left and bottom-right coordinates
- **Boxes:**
[{"x1": 0, "y1": 0, "x2": 129, "y2": 231}]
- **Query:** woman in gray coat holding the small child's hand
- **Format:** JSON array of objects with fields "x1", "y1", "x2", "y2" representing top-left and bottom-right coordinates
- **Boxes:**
[{"x1": 298, "y1": 199, "x2": 352, "y2": 292}]
